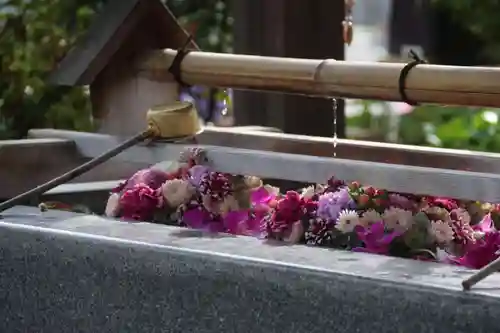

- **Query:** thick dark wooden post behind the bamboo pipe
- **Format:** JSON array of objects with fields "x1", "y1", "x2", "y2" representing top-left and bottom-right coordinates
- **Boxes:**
[{"x1": 234, "y1": 0, "x2": 345, "y2": 137}]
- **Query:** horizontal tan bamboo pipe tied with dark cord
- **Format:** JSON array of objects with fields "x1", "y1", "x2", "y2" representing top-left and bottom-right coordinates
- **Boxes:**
[{"x1": 138, "y1": 49, "x2": 500, "y2": 107}]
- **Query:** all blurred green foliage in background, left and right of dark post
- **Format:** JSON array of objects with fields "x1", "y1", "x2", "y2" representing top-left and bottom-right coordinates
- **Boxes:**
[{"x1": 0, "y1": 0, "x2": 500, "y2": 151}]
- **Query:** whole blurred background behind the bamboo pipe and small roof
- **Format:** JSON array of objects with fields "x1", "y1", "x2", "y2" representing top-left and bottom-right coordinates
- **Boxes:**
[{"x1": 0, "y1": 0, "x2": 500, "y2": 152}]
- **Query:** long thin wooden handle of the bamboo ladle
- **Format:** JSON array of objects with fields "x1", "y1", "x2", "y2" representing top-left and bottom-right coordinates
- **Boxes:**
[{"x1": 0, "y1": 129, "x2": 153, "y2": 212}]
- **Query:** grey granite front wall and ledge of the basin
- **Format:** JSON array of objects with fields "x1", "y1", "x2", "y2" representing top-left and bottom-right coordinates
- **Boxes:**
[{"x1": 0, "y1": 207, "x2": 500, "y2": 333}]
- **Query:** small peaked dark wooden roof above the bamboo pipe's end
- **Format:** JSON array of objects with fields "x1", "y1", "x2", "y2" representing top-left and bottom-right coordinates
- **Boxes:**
[{"x1": 49, "y1": 0, "x2": 197, "y2": 86}]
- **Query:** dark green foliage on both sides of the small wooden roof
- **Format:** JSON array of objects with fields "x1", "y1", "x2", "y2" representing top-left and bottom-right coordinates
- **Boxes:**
[{"x1": 0, "y1": 0, "x2": 232, "y2": 139}]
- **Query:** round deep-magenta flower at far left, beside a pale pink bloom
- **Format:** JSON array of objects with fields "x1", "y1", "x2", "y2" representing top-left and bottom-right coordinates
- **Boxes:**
[{"x1": 120, "y1": 184, "x2": 163, "y2": 221}]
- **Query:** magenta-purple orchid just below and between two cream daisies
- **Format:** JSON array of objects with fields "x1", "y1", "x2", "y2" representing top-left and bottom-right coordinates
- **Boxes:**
[{"x1": 353, "y1": 222, "x2": 401, "y2": 254}]
